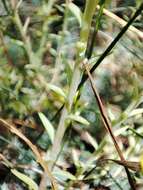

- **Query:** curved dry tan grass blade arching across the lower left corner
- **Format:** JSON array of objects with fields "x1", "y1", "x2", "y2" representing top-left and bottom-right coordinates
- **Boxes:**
[{"x1": 0, "y1": 118, "x2": 58, "y2": 190}]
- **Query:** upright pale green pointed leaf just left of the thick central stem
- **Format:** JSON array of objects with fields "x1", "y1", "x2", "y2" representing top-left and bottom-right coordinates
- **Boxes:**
[{"x1": 38, "y1": 112, "x2": 55, "y2": 143}]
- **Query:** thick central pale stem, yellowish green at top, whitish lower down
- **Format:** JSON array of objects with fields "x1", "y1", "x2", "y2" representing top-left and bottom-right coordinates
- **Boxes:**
[{"x1": 50, "y1": 0, "x2": 98, "y2": 168}]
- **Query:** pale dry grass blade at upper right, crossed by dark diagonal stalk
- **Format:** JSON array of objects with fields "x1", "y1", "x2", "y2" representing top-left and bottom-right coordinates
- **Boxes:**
[{"x1": 97, "y1": 5, "x2": 143, "y2": 40}]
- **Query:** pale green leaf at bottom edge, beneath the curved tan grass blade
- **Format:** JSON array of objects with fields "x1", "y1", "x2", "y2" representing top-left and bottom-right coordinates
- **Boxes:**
[{"x1": 11, "y1": 169, "x2": 38, "y2": 190}]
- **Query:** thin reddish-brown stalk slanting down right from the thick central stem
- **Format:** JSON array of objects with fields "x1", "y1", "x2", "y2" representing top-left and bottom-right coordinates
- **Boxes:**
[{"x1": 83, "y1": 59, "x2": 136, "y2": 190}]
